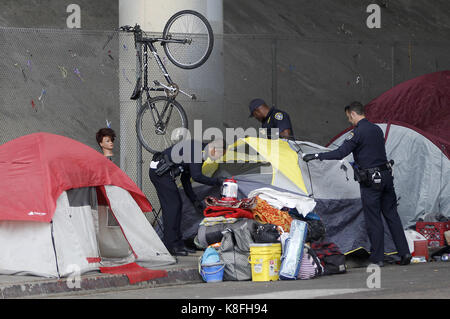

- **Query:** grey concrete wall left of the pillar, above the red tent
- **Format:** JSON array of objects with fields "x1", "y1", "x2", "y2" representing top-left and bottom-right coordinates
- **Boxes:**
[{"x1": 0, "y1": 0, "x2": 120, "y2": 149}]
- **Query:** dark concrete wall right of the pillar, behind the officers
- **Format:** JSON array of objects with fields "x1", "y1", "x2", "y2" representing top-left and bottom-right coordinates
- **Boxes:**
[{"x1": 224, "y1": 0, "x2": 450, "y2": 144}]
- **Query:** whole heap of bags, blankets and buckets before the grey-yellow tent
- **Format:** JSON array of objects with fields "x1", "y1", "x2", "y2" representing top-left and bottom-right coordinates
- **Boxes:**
[{"x1": 197, "y1": 190, "x2": 346, "y2": 281}]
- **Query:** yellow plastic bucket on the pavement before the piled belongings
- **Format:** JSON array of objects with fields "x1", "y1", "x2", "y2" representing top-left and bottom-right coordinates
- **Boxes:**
[{"x1": 248, "y1": 243, "x2": 281, "y2": 281}]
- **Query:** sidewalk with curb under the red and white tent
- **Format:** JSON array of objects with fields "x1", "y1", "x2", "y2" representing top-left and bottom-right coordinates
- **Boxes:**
[{"x1": 0, "y1": 251, "x2": 203, "y2": 299}]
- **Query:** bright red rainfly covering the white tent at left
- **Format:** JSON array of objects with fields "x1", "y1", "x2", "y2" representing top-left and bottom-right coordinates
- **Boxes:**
[{"x1": 0, "y1": 133, "x2": 152, "y2": 222}]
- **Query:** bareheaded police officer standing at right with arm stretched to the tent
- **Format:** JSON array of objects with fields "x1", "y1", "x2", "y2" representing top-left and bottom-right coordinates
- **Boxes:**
[{"x1": 303, "y1": 102, "x2": 411, "y2": 267}]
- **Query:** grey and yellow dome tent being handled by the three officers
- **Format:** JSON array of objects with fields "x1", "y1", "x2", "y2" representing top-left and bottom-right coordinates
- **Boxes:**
[{"x1": 174, "y1": 139, "x2": 395, "y2": 254}]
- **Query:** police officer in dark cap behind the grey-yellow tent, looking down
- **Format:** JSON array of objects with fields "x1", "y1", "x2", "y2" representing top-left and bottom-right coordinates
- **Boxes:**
[{"x1": 248, "y1": 99, "x2": 294, "y2": 138}]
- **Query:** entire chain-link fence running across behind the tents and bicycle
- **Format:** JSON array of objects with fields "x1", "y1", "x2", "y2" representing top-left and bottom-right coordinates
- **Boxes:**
[{"x1": 0, "y1": 28, "x2": 450, "y2": 234}]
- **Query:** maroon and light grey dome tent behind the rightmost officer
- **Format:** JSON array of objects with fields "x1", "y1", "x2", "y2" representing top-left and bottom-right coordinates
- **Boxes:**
[{"x1": 328, "y1": 71, "x2": 450, "y2": 226}]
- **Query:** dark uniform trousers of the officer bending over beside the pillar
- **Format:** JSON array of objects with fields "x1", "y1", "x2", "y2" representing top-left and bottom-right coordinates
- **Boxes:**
[{"x1": 149, "y1": 168, "x2": 184, "y2": 250}]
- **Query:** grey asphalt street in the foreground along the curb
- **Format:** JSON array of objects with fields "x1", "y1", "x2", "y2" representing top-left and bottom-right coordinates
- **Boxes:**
[{"x1": 50, "y1": 262, "x2": 450, "y2": 300}]
